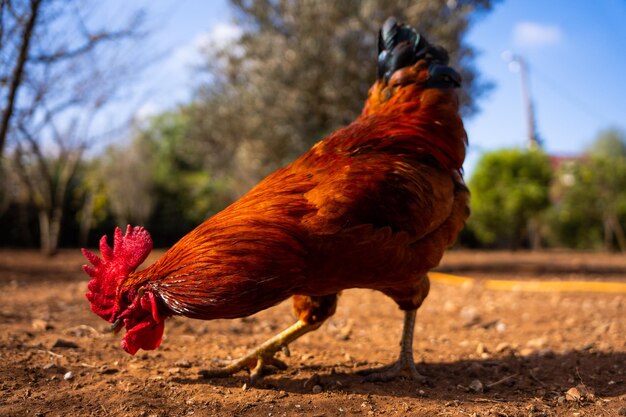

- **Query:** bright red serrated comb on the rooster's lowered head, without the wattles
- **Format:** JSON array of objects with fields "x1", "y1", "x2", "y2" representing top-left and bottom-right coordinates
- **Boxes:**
[{"x1": 82, "y1": 225, "x2": 152, "y2": 322}]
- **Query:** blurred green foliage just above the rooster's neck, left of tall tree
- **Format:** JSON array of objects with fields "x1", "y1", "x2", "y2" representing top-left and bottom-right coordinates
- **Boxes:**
[{"x1": 120, "y1": 108, "x2": 231, "y2": 245}]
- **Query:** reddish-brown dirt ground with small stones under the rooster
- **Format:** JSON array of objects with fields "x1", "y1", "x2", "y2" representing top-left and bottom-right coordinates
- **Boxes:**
[{"x1": 0, "y1": 250, "x2": 626, "y2": 417}]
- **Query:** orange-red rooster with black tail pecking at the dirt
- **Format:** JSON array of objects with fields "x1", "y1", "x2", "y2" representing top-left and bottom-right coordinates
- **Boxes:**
[{"x1": 83, "y1": 18, "x2": 469, "y2": 383}]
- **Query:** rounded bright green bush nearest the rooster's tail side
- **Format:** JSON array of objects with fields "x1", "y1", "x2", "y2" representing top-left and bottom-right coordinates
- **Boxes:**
[{"x1": 468, "y1": 149, "x2": 552, "y2": 249}]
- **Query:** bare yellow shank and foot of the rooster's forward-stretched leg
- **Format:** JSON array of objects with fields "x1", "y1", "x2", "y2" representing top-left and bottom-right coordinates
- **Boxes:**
[{"x1": 200, "y1": 320, "x2": 322, "y2": 386}]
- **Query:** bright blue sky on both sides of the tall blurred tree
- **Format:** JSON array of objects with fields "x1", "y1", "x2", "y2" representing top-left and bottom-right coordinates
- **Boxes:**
[{"x1": 128, "y1": 0, "x2": 626, "y2": 174}]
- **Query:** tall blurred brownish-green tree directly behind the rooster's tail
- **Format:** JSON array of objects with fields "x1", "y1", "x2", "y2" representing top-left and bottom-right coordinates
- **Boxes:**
[{"x1": 190, "y1": 0, "x2": 495, "y2": 191}]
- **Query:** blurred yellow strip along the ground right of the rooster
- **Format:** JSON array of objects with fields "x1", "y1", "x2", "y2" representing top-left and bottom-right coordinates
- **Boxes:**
[{"x1": 428, "y1": 272, "x2": 626, "y2": 294}]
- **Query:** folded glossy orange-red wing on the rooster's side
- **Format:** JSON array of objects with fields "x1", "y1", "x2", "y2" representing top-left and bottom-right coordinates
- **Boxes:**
[{"x1": 293, "y1": 118, "x2": 455, "y2": 241}]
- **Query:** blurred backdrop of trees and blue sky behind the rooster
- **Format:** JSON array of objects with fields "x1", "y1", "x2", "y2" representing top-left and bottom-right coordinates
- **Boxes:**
[{"x1": 0, "y1": 0, "x2": 626, "y2": 255}]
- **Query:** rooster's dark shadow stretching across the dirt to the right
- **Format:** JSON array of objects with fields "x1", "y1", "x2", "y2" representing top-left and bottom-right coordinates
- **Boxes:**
[{"x1": 173, "y1": 351, "x2": 626, "y2": 402}]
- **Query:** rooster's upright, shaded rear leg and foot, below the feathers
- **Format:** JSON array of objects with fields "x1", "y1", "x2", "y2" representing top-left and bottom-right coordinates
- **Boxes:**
[{"x1": 360, "y1": 310, "x2": 424, "y2": 381}]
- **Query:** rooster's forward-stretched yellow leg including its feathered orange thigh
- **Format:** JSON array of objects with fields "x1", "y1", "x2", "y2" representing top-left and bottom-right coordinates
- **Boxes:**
[{"x1": 201, "y1": 294, "x2": 337, "y2": 385}]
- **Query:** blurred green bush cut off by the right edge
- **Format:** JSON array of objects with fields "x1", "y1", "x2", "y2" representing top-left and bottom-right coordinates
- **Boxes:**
[{"x1": 553, "y1": 129, "x2": 626, "y2": 252}]
